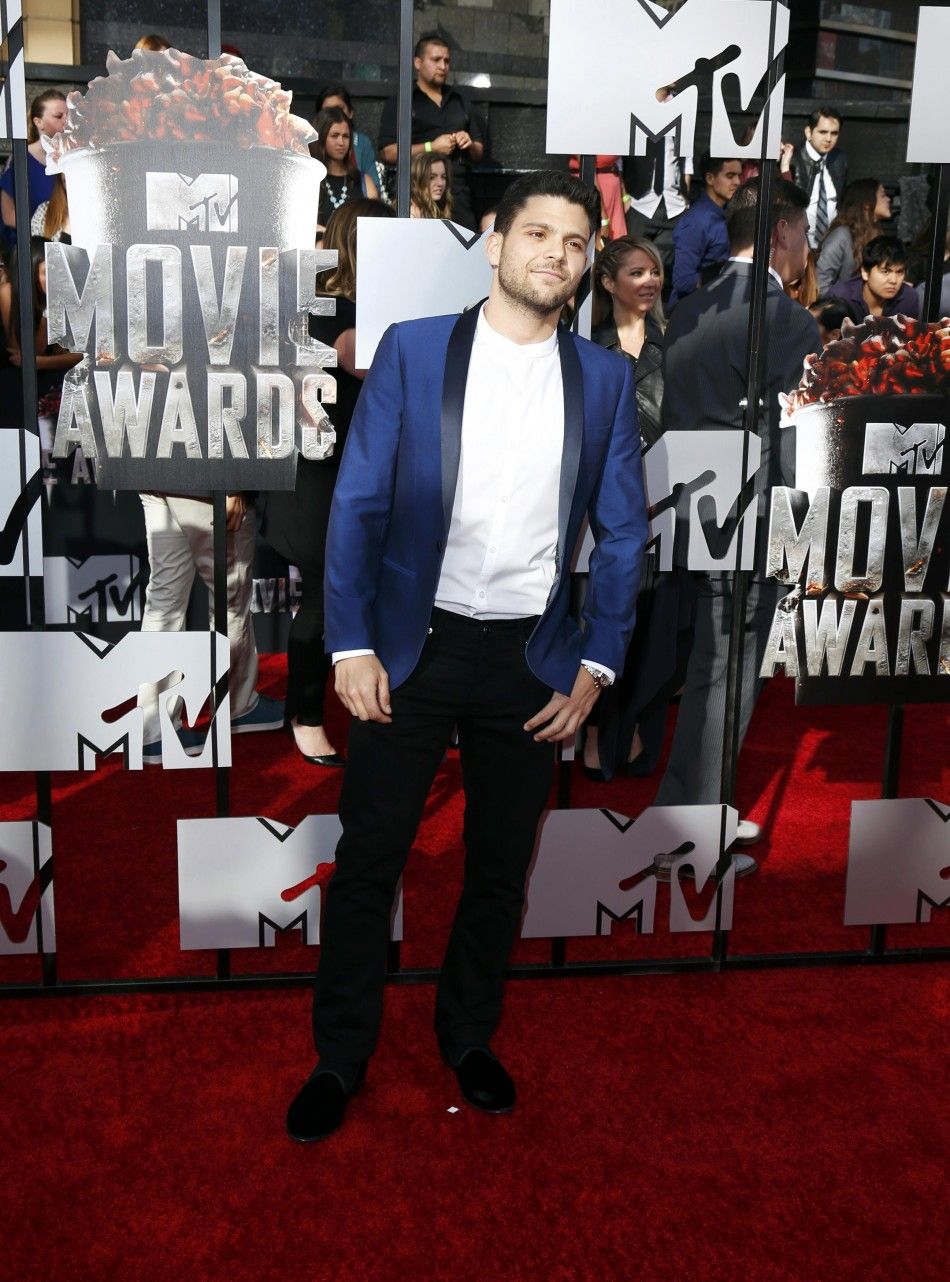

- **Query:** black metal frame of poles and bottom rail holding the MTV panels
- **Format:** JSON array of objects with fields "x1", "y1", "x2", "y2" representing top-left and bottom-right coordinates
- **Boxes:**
[{"x1": 0, "y1": 0, "x2": 950, "y2": 997}]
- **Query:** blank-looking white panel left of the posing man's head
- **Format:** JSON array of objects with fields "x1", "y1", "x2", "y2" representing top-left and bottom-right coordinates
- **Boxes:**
[{"x1": 356, "y1": 218, "x2": 491, "y2": 369}]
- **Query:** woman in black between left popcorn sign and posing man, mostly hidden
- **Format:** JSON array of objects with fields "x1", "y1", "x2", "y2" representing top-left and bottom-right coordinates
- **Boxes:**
[{"x1": 262, "y1": 199, "x2": 394, "y2": 767}]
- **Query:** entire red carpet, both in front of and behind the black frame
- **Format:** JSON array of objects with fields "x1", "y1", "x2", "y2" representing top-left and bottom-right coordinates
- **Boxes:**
[{"x1": 0, "y1": 659, "x2": 950, "y2": 1282}]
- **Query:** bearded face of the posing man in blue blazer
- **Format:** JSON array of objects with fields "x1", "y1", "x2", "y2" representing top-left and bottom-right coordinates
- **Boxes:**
[{"x1": 486, "y1": 196, "x2": 591, "y2": 317}]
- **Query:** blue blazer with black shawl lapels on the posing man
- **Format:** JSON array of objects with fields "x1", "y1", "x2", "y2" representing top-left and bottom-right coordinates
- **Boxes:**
[{"x1": 326, "y1": 308, "x2": 646, "y2": 694}]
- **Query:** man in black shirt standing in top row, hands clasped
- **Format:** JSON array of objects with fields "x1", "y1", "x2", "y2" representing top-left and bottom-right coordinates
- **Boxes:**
[{"x1": 379, "y1": 32, "x2": 485, "y2": 231}]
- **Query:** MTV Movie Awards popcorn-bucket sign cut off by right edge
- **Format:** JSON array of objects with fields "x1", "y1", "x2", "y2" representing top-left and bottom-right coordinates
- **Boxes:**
[{"x1": 762, "y1": 317, "x2": 950, "y2": 704}]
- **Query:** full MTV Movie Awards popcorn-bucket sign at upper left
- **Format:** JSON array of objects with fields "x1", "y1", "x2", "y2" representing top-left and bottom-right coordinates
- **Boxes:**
[{"x1": 46, "y1": 50, "x2": 336, "y2": 494}]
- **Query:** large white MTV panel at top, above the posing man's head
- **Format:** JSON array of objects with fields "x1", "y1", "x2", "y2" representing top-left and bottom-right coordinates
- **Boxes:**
[{"x1": 546, "y1": 0, "x2": 788, "y2": 156}]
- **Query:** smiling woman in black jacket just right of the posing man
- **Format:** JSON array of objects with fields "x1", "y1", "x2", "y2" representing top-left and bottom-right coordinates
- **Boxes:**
[{"x1": 583, "y1": 236, "x2": 692, "y2": 779}]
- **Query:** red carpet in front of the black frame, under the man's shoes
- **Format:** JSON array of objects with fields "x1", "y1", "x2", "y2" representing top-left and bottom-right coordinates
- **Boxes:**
[{"x1": 0, "y1": 965, "x2": 950, "y2": 1282}]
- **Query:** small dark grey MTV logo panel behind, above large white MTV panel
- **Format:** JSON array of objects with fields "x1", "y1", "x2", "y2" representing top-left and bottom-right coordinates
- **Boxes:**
[{"x1": 42, "y1": 554, "x2": 149, "y2": 627}]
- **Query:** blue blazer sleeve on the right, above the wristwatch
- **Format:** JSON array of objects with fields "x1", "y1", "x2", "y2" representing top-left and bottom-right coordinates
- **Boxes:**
[{"x1": 583, "y1": 363, "x2": 647, "y2": 672}]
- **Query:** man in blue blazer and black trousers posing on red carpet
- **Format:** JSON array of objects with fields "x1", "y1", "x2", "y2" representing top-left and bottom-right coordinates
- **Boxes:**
[{"x1": 287, "y1": 171, "x2": 646, "y2": 1140}]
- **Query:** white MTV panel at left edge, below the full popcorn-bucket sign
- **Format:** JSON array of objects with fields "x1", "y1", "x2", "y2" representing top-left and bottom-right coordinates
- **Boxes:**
[{"x1": 0, "y1": 632, "x2": 231, "y2": 770}]
